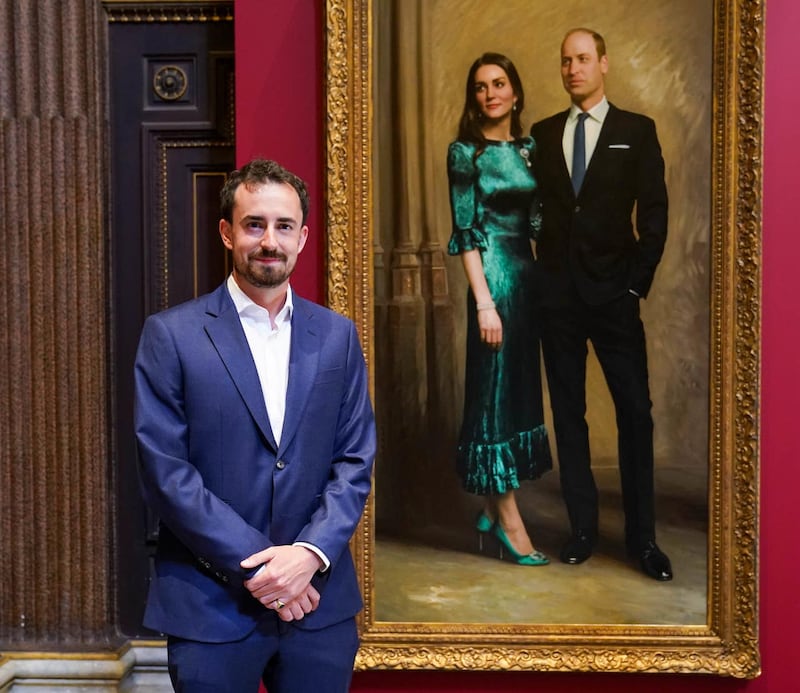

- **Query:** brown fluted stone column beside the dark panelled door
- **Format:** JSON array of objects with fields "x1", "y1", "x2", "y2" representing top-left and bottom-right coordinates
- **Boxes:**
[{"x1": 0, "y1": 0, "x2": 114, "y2": 650}]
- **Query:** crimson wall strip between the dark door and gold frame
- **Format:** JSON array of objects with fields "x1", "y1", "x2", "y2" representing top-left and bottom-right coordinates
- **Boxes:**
[{"x1": 235, "y1": 0, "x2": 325, "y2": 303}]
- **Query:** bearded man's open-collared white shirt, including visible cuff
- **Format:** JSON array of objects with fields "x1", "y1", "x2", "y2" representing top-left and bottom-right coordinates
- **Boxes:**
[{"x1": 228, "y1": 274, "x2": 330, "y2": 572}]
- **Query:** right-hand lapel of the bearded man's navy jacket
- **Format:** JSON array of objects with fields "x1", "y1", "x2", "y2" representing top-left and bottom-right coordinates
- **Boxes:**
[{"x1": 279, "y1": 294, "x2": 321, "y2": 452}]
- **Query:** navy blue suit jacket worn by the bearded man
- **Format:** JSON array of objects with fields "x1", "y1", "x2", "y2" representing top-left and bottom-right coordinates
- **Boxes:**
[{"x1": 135, "y1": 284, "x2": 375, "y2": 642}]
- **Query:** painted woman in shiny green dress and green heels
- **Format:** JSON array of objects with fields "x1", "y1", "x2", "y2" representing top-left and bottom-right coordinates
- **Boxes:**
[{"x1": 447, "y1": 53, "x2": 552, "y2": 566}]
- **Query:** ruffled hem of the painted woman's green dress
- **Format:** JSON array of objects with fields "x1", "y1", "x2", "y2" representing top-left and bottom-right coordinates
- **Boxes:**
[{"x1": 456, "y1": 424, "x2": 553, "y2": 496}]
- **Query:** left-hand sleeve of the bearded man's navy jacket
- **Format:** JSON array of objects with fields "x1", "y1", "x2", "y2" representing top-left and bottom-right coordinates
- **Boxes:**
[{"x1": 134, "y1": 315, "x2": 271, "y2": 583}]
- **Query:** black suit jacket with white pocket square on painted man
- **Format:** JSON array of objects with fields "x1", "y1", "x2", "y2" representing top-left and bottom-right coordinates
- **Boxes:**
[{"x1": 531, "y1": 105, "x2": 667, "y2": 305}]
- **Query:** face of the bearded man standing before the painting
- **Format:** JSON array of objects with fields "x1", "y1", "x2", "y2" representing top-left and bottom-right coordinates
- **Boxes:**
[{"x1": 219, "y1": 183, "x2": 308, "y2": 292}]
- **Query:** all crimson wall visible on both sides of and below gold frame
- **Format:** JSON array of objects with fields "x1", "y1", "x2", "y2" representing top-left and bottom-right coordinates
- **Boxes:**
[{"x1": 236, "y1": 0, "x2": 800, "y2": 693}]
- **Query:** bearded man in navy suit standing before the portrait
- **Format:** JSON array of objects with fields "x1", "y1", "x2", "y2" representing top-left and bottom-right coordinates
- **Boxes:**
[{"x1": 135, "y1": 160, "x2": 375, "y2": 693}]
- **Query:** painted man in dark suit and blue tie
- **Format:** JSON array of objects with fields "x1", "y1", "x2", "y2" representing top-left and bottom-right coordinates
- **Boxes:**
[{"x1": 531, "y1": 29, "x2": 672, "y2": 580}]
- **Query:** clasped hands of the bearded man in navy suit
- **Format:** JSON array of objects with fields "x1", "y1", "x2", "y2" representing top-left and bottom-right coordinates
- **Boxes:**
[{"x1": 240, "y1": 546, "x2": 322, "y2": 622}]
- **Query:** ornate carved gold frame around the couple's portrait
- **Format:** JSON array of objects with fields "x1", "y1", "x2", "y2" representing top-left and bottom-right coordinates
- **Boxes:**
[{"x1": 326, "y1": 0, "x2": 765, "y2": 678}]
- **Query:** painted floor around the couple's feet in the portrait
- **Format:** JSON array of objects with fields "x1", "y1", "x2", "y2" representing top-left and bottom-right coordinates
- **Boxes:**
[{"x1": 374, "y1": 467, "x2": 708, "y2": 625}]
